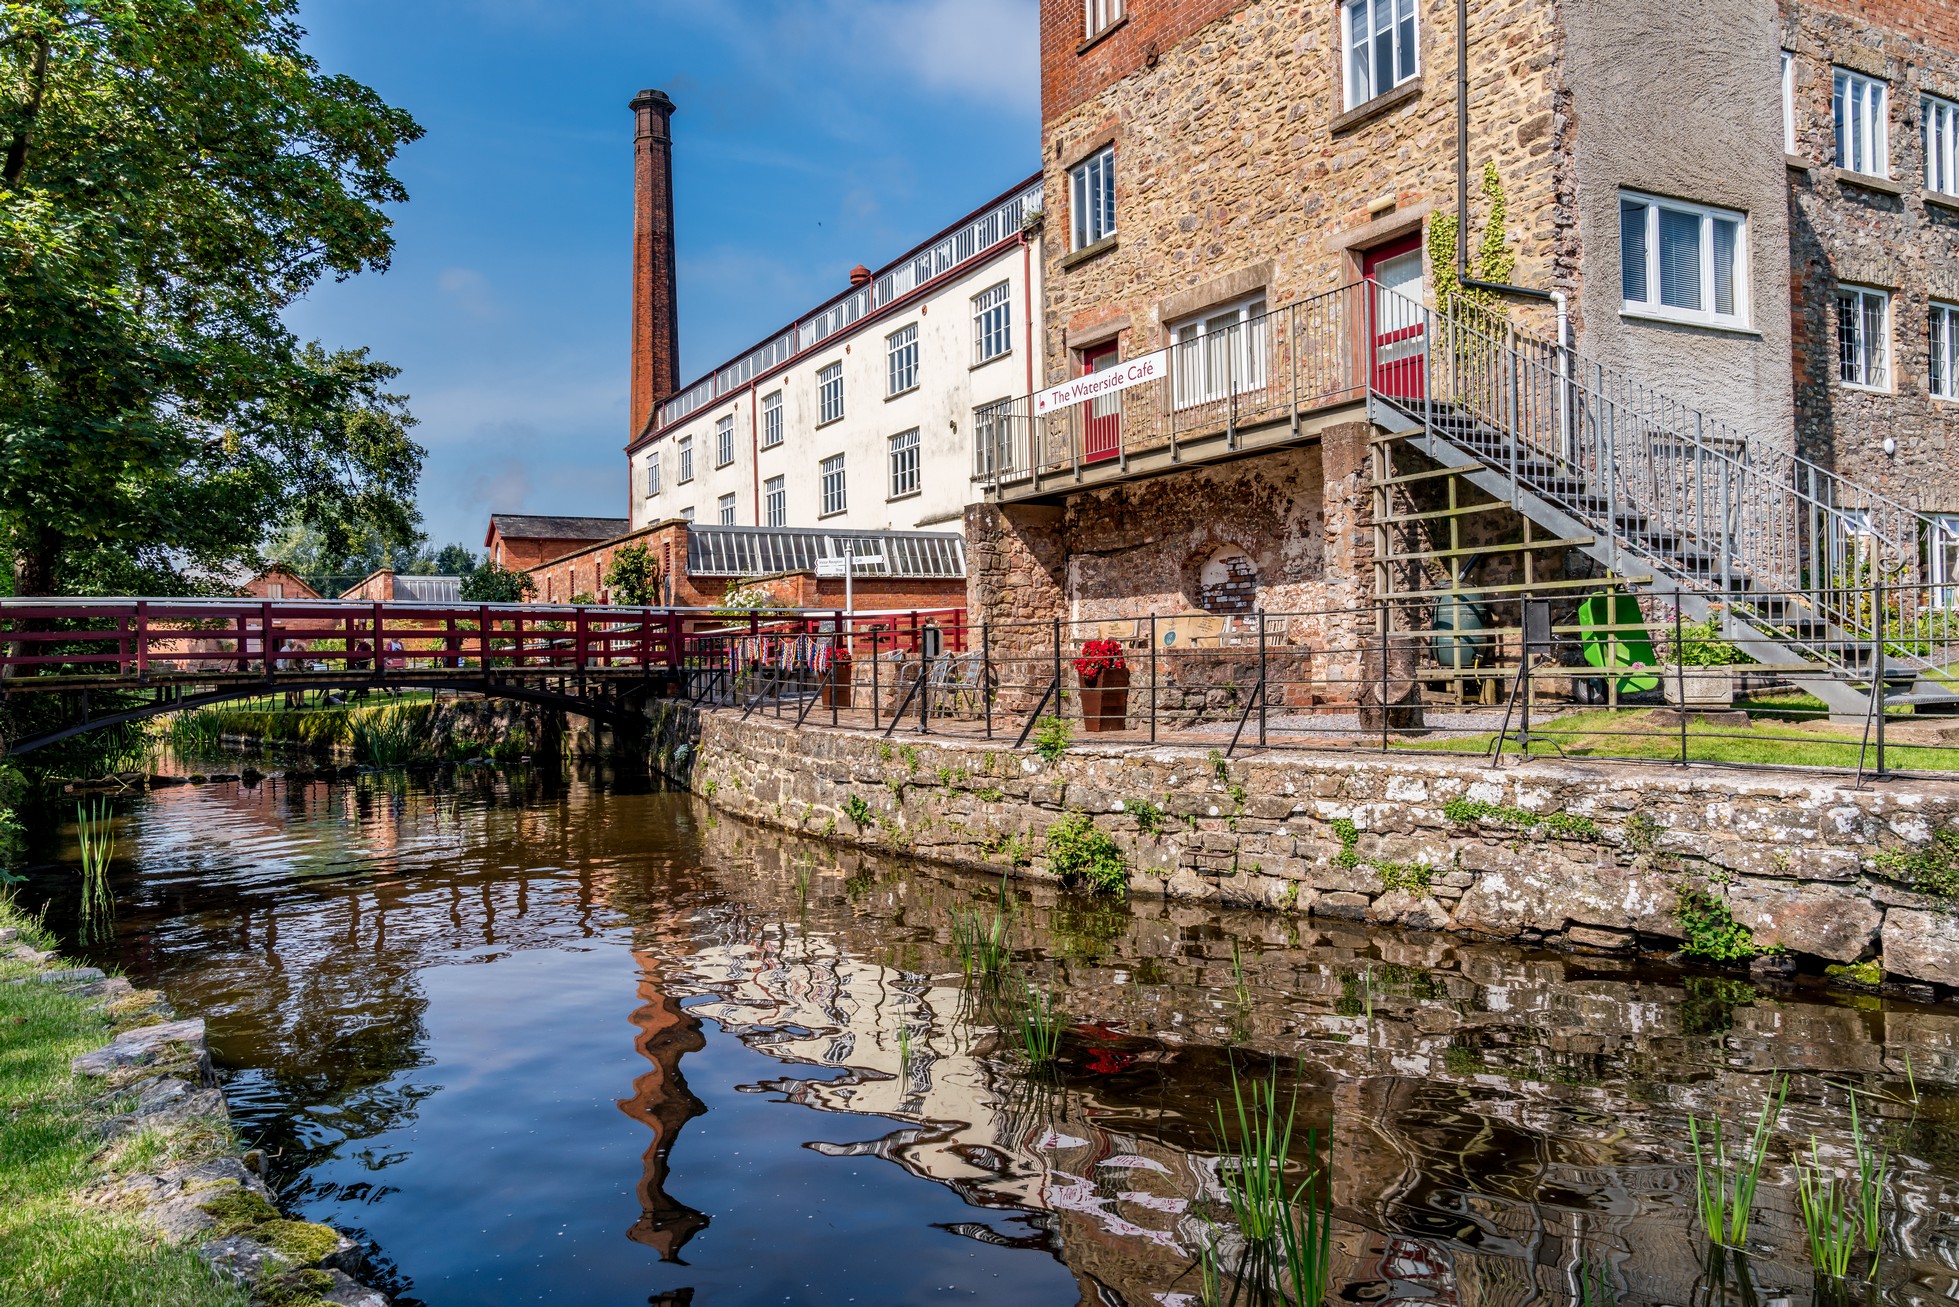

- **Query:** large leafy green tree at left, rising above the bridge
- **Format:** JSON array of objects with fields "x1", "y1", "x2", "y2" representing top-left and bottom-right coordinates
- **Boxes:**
[{"x1": 0, "y1": 0, "x2": 423, "y2": 594}]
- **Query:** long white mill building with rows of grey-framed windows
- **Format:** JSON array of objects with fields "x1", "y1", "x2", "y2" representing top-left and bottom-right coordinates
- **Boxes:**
[{"x1": 627, "y1": 176, "x2": 1042, "y2": 531}]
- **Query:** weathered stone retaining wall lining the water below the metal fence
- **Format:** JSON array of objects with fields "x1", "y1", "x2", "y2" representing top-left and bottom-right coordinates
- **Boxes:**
[{"x1": 650, "y1": 703, "x2": 1959, "y2": 986}]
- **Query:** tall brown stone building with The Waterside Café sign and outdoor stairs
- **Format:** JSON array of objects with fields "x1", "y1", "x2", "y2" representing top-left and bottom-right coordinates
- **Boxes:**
[{"x1": 968, "y1": 0, "x2": 1959, "y2": 705}]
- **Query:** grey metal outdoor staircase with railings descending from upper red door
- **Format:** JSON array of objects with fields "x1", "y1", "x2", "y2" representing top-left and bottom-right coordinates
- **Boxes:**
[{"x1": 1369, "y1": 284, "x2": 1959, "y2": 717}]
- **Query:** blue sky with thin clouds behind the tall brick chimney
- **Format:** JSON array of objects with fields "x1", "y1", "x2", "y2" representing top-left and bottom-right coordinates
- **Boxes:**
[{"x1": 290, "y1": 0, "x2": 1040, "y2": 547}]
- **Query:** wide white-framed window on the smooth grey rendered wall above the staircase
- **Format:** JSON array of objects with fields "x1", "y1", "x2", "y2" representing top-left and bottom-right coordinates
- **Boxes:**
[{"x1": 1618, "y1": 190, "x2": 1747, "y2": 327}]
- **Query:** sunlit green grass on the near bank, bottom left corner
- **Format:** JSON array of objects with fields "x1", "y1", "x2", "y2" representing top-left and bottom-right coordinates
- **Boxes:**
[{"x1": 0, "y1": 899, "x2": 247, "y2": 1307}]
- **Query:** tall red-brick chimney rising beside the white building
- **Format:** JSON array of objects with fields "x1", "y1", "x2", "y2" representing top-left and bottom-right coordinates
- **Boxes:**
[{"x1": 627, "y1": 90, "x2": 680, "y2": 439}]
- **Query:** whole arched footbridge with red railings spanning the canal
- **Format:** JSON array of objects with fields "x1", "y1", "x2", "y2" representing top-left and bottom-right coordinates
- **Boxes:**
[{"x1": 0, "y1": 598, "x2": 964, "y2": 754}]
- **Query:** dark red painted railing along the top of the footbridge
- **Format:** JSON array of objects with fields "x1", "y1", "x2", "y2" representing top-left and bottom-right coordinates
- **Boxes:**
[{"x1": 0, "y1": 598, "x2": 966, "y2": 690}]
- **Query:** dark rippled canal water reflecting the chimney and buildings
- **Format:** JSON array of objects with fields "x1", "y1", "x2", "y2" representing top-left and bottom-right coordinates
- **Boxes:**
[{"x1": 27, "y1": 768, "x2": 1959, "y2": 1307}]
